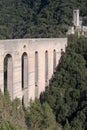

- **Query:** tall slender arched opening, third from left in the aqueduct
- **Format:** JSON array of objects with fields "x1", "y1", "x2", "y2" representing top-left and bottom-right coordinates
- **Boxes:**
[{"x1": 35, "y1": 51, "x2": 38, "y2": 97}]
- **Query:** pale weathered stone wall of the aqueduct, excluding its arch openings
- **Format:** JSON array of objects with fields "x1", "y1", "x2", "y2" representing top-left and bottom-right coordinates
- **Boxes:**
[{"x1": 0, "y1": 38, "x2": 67, "y2": 105}]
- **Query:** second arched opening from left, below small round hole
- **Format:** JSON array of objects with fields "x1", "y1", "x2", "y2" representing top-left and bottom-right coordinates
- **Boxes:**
[{"x1": 22, "y1": 52, "x2": 28, "y2": 89}]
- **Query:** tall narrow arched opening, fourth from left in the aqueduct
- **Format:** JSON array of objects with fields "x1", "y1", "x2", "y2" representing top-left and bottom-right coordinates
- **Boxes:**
[{"x1": 45, "y1": 51, "x2": 48, "y2": 86}]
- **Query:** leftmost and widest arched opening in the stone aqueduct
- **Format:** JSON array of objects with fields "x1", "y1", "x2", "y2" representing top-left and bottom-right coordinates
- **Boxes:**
[{"x1": 4, "y1": 54, "x2": 13, "y2": 99}]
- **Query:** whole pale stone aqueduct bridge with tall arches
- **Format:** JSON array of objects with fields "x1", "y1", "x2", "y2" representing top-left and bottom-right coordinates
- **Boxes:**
[{"x1": 0, "y1": 38, "x2": 67, "y2": 105}]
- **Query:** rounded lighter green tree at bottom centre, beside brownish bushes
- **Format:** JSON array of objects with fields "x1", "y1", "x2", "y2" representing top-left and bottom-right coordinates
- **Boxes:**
[{"x1": 26, "y1": 100, "x2": 58, "y2": 130}]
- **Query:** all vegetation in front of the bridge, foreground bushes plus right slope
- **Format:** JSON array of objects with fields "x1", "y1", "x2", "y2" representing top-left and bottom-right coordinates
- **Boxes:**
[{"x1": 0, "y1": 36, "x2": 87, "y2": 130}]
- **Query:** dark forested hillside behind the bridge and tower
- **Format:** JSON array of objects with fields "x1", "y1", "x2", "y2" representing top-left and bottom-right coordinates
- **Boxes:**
[{"x1": 0, "y1": 0, "x2": 87, "y2": 39}]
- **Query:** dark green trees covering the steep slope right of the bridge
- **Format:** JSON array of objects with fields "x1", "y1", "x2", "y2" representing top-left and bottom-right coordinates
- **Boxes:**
[{"x1": 41, "y1": 36, "x2": 87, "y2": 130}]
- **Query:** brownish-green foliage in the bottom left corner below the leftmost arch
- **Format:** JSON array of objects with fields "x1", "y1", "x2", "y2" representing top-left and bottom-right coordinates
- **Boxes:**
[{"x1": 0, "y1": 92, "x2": 27, "y2": 130}]
